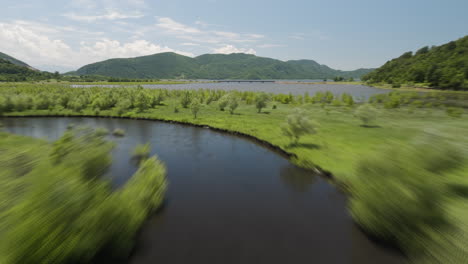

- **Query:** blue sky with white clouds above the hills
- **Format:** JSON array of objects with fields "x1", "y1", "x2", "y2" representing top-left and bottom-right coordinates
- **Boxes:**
[{"x1": 0, "y1": 0, "x2": 468, "y2": 72}]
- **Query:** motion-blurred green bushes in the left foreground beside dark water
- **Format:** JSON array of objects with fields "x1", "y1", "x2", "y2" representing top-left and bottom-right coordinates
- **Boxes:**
[{"x1": 0, "y1": 129, "x2": 166, "y2": 264}]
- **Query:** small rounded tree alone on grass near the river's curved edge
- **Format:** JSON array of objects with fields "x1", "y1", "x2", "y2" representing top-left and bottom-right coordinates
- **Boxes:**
[{"x1": 281, "y1": 109, "x2": 316, "y2": 144}]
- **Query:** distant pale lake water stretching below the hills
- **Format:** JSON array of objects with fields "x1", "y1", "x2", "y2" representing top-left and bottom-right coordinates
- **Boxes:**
[{"x1": 73, "y1": 83, "x2": 389, "y2": 99}]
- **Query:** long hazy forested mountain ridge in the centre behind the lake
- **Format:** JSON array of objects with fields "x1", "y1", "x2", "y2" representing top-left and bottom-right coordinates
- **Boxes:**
[{"x1": 68, "y1": 52, "x2": 371, "y2": 79}]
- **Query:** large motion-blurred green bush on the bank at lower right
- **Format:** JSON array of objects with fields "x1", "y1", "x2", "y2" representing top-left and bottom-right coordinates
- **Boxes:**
[{"x1": 350, "y1": 136, "x2": 463, "y2": 254}]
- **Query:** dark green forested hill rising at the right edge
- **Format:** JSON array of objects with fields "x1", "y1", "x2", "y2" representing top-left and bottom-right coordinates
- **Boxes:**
[{"x1": 363, "y1": 36, "x2": 468, "y2": 90}]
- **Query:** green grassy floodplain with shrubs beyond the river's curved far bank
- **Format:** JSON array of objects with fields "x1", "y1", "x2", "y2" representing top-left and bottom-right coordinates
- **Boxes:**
[{"x1": 0, "y1": 84, "x2": 468, "y2": 263}]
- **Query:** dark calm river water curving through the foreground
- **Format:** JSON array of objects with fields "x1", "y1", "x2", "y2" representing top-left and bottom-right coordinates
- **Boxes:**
[{"x1": 0, "y1": 118, "x2": 402, "y2": 264}]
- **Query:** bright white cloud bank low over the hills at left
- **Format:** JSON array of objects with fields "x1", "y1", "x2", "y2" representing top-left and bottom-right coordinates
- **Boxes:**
[{"x1": 0, "y1": 20, "x2": 194, "y2": 68}]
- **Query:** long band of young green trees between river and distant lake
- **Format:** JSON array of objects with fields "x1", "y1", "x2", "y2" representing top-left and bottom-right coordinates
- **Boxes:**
[{"x1": 0, "y1": 85, "x2": 355, "y2": 115}]
